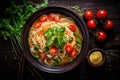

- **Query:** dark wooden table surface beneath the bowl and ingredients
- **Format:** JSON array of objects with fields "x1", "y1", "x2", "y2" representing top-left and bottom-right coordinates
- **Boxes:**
[{"x1": 0, "y1": 0, "x2": 120, "y2": 80}]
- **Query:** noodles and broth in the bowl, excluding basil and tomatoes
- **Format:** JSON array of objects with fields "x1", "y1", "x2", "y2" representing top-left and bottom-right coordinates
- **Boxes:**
[{"x1": 28, "y1": 14, "x2": 82, "y2": 66}]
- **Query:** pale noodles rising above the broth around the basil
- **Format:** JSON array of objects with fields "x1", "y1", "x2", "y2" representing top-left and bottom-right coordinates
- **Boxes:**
[{"x1": 28, "y1": 17, "x2": 82, "y2": 65}]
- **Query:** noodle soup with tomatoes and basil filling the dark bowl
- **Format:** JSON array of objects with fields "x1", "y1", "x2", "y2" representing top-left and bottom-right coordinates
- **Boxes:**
[{"x1": 28, "y1": 13, "x2": 83, "y2": 66}]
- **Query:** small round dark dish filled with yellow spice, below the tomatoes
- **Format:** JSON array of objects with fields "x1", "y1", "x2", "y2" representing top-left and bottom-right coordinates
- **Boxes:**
[{"x1": 87, "y1": 48, "x2": 105, "y2": 67}]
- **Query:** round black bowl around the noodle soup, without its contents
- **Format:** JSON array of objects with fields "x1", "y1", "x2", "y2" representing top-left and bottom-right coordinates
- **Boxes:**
[{"x1": 21, "y1": 6, "x2": 89, "y2": 73}]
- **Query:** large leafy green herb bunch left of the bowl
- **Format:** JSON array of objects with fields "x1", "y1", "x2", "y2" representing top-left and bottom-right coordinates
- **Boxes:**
[{"x1": 0, "y1": 0, "x2": 48, "y2": 58}]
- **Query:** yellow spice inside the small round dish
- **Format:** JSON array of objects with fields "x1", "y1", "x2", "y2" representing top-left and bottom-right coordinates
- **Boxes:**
[{"x1": 90, "y1": 51, "x2": 102, "y2": 64}]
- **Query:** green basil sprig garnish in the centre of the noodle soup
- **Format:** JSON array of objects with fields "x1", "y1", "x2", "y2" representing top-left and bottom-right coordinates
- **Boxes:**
[{"x1": 44, "y1": 26, "x2": 67, "y2": 49}]
